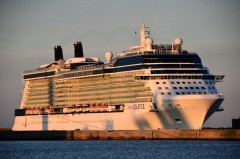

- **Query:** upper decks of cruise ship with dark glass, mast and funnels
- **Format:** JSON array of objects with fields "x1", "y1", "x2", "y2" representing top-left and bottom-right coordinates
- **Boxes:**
[{"x1": 23, "y1": 24, "x2": 224, "y2": 82}]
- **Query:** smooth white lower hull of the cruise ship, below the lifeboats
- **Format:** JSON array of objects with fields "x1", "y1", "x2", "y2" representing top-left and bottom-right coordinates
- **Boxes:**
[{"x1": 13, "y1": 95, "x2": 223, "y2": 131}]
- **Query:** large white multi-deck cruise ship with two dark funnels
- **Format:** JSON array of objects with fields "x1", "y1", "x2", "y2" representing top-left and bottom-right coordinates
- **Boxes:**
[{"x1": 12, "y1": 24, "x2": 224, "y2": 131}]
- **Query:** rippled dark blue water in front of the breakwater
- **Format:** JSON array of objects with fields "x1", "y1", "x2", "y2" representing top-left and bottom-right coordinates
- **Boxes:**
[{"x1": 0, "y1": 140, "x2": 240, "y2": 159}]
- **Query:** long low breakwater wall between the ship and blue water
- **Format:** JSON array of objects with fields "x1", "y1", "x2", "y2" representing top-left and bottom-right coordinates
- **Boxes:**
[{"x1": 0, "y1": 129, "x2": 240, "y2": 141}]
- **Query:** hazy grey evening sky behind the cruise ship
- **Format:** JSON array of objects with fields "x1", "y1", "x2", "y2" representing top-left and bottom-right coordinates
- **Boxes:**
[{"x1": 0, "y1": 0, "x2": 240, "y2": 128}]
